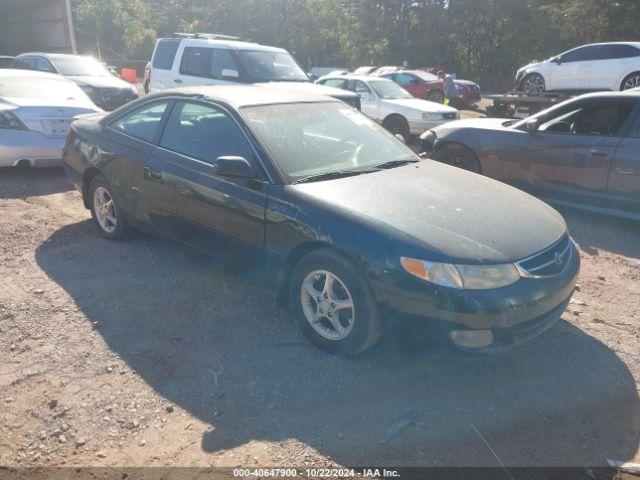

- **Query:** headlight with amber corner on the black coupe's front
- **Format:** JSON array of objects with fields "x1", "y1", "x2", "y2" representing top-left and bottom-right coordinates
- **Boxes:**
[{"x1": 400, "y1": 257, "x2": 520, "y2": 290}]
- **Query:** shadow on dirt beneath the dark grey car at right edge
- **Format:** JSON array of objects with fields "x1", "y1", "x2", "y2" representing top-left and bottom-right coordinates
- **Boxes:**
[{"x1": 554, "y1": 206, "x2": 640, "y2": 258}]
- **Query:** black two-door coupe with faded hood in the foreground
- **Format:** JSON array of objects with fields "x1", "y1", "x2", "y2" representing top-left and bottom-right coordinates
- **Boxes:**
[{"x1": 64, "y1": 86, "x2": 580, "y2": 354}]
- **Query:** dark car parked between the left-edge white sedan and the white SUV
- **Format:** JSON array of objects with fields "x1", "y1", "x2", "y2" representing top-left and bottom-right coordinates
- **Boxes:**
[{"x1": 13, "y1": 52, "x2": 139, "y2": 111}]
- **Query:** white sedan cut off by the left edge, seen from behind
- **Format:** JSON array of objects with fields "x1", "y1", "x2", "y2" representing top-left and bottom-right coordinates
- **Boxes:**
[{"x1": 0, "y1": 69, "x2": 102, "y2": 167}]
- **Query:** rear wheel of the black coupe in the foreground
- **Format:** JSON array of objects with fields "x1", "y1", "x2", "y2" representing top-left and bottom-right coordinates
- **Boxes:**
[{"x1": 89, "y1": 175, "x2": 130, "y2": 240}]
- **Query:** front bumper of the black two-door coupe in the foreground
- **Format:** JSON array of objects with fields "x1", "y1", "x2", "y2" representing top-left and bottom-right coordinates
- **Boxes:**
[{"x1": 374, "y1": 242, "x2": 580, "y2": 352}]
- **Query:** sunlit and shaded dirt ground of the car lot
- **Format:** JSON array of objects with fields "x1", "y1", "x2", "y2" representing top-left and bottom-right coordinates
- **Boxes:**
[{"x1": 0, "y1": 106, "x2": 640, "y2": 467}]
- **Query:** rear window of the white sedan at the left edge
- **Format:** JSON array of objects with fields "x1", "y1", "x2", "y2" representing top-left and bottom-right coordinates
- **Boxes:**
[{"x1": 0, "y1": 76, "x2": 89, "y2": 101}]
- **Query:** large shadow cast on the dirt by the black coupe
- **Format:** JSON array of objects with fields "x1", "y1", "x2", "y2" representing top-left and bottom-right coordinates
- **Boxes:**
[{"x1": 36, "y1": 222, "x2": 640, "y2": 466}]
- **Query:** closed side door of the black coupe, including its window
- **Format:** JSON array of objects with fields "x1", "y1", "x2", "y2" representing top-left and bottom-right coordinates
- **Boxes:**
[{"x1": 143, "y1": 102, "x2": 268, "y2": 268}]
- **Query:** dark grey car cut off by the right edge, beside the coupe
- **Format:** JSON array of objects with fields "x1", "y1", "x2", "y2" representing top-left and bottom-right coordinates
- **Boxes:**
[{"x1": 421, "y1": 90, "x2": 640, "y2": 220}]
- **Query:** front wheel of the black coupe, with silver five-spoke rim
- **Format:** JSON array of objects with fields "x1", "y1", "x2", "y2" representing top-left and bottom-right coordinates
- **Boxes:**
[{"x1": 290, "y1": 249, "x2": 380, "y2": 356}]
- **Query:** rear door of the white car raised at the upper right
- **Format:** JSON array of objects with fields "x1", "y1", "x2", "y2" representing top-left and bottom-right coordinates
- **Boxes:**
[{"x1": 590, "y1": 43, "x2": 640, "y2": 91}]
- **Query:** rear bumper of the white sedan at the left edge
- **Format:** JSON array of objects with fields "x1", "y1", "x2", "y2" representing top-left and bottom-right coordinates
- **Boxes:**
[{"x1": 0, "y1": 130, "x2": 65, "y2": 167}]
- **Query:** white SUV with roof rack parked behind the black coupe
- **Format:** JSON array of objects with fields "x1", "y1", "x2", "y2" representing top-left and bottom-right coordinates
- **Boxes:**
[{"x1": 145, "y1": 33, "x2": 360, "y2": 109}]
